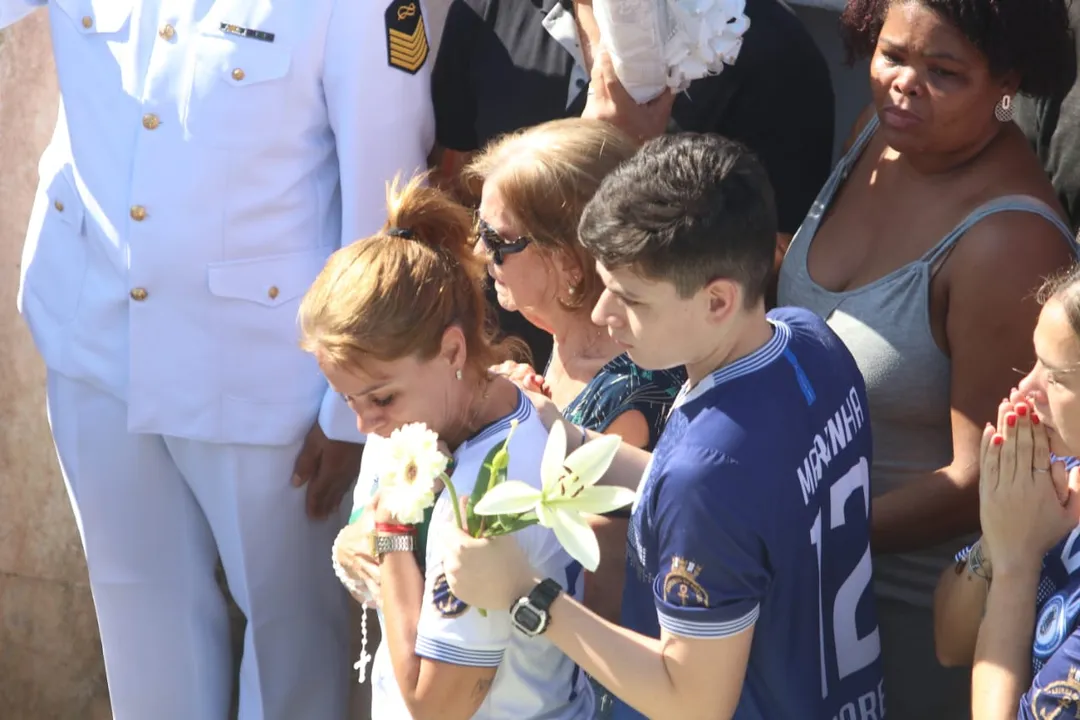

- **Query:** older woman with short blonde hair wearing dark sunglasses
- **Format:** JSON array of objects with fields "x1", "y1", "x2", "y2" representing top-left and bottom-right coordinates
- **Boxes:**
[{"x1": 463, "y1": 118, "x2": 685, "y2": 715}]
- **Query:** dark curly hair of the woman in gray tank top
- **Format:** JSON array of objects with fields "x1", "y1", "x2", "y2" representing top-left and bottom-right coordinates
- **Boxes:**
[{"x1": 840, "y1": 0, "x2": 1080, "y2": 97}]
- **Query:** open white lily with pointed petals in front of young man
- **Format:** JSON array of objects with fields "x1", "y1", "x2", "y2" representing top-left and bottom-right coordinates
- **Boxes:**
[{"x1": 474, "y1": 422, "x2": 634, "y2": 571}]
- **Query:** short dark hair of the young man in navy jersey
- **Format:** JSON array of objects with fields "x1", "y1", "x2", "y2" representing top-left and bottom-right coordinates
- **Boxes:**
[{"x1": 578, "y1": 133, "x2": 778, "y2": 305}]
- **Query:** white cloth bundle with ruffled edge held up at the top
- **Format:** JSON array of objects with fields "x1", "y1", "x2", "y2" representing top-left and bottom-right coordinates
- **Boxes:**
[{"x1": 593, "y1": 0, "x2": 750, "y2": 104}]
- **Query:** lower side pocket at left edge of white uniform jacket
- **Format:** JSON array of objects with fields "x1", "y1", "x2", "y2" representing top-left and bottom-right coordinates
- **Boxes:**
[{"x1": 23, "y1": 166, "x2": 87, "y2": 323}]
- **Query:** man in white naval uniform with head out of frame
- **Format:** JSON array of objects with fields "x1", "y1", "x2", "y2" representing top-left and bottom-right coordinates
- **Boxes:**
[{"x1": 0, "y1": 0, "x2": 433, "y2": 720}]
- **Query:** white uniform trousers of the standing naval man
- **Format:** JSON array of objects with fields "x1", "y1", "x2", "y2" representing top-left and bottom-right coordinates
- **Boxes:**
[{"x1": 48, "y1": 371, "x2": 349, "y2": 720}]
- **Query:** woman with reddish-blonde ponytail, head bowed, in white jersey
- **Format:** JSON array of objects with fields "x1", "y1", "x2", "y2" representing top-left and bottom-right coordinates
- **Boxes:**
[{"x1": 299, "y1": 178, "x2": 593, "y2": 720}]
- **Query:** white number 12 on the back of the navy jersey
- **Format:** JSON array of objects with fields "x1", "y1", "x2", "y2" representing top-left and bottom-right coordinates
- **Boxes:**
[{"x1": 810, "y1": 458, "x2": 881, "y2": 697}]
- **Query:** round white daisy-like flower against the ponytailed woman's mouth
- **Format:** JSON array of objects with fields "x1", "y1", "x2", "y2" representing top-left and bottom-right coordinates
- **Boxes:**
[{"x1": 378, "y1": 422, "x2": 449, "y2": 525}]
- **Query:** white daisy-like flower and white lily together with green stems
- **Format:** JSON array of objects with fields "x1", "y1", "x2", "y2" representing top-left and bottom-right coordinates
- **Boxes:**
[{"x1": 379, "y1": 422, "x2": 634, "y2": 612}]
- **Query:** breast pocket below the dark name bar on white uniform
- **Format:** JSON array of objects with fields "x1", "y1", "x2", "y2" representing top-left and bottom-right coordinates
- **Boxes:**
[{"x1": 185, "y1": 35, "x2": 295, "y2": 148}]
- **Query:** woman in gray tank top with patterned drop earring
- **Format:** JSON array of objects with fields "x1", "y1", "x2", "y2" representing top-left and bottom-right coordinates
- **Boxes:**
[{"x1": 779, "y1": 0, "x2": 1074, "y2": 720}]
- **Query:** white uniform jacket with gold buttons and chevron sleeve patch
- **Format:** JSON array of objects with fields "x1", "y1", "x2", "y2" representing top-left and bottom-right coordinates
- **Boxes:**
[{"x1": 0, "y1": 0, "x2": 434, "y2": 445}]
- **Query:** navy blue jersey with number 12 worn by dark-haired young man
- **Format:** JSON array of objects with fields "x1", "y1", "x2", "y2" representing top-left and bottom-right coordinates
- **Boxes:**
[{"x1": 616, "y1": 309, "x2": 885, "y2": 720}]
